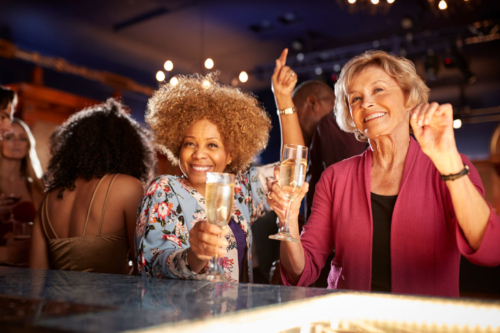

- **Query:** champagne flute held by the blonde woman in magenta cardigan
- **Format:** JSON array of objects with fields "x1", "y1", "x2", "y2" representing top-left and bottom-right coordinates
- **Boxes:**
[{"x1": 269, "y1": 144, "x2": 307, "y2": 242}]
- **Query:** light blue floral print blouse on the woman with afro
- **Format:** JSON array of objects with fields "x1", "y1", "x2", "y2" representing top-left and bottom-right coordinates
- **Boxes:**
[{"x1": 135, "y1": 164, "x2": 276, "y2": 282}]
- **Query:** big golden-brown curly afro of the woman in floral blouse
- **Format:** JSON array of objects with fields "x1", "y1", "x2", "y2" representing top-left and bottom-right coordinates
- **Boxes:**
[{"x1": 146, "y1": 73, "x2": 271, "y2": 173}]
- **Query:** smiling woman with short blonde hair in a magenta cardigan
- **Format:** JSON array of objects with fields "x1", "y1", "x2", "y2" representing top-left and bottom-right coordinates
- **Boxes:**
[{"x1": 268, "y1": 51, "x2": 500, "y2": 297}]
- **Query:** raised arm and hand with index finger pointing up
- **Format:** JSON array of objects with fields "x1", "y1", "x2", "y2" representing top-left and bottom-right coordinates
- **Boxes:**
[{"x1": 272, "y1": 49, "x2": 304, "y2": 156}]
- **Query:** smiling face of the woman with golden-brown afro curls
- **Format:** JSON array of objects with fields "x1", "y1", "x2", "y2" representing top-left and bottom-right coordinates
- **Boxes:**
[{"x1": 179, "y1": 119, "x2": 231, "y2": 188}]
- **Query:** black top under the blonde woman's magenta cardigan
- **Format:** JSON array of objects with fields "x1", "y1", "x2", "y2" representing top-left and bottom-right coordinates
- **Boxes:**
[{"x1": 371, "y1": 193, "x2": 398, "y2": 292}]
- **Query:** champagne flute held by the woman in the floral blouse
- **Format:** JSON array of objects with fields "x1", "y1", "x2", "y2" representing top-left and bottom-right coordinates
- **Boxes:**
[{"x1": 205, "y1": 172, "x2": 234, "y2": 282}]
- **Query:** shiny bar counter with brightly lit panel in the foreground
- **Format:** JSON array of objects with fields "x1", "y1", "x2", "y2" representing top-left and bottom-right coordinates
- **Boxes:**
[{"x1": 0, "y1": 267, "x2": 500, "y2": 333}]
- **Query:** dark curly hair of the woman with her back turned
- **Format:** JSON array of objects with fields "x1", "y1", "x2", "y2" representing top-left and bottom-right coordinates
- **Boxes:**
[{"x1": 45, "y1": 98, "x2": 156, "y2": 198}]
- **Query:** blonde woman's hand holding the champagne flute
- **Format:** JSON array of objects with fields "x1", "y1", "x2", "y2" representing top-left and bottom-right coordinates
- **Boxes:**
[{"x1": 267, "y1": 166, "x2": 309, "y2": 227}]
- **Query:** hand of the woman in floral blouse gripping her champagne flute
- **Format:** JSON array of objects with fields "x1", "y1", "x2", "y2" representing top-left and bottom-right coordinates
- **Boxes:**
[{"x1": 189, "y1": 221, "x2": 229, "y2": 261}]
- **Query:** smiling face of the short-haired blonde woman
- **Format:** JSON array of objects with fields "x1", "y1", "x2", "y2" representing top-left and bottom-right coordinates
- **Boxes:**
[{"x1": 347, "y1": 66, "x2": 410, "y2": 139}]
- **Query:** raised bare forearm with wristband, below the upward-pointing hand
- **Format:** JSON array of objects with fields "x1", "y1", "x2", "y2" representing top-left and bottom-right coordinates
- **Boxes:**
[{"x1": 276, "y1": 95, "x2": 304, "y2": 154}]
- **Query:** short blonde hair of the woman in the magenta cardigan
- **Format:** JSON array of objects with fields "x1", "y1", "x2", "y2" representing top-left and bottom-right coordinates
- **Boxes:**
[{"x1": 335, "y1": 51, "x2": 430, "y2": 141}]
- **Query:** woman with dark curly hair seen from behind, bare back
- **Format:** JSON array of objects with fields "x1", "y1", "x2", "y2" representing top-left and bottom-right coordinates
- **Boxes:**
[{"x1": 30, "y1": 99, "x2": 155, "y2": 274}]
